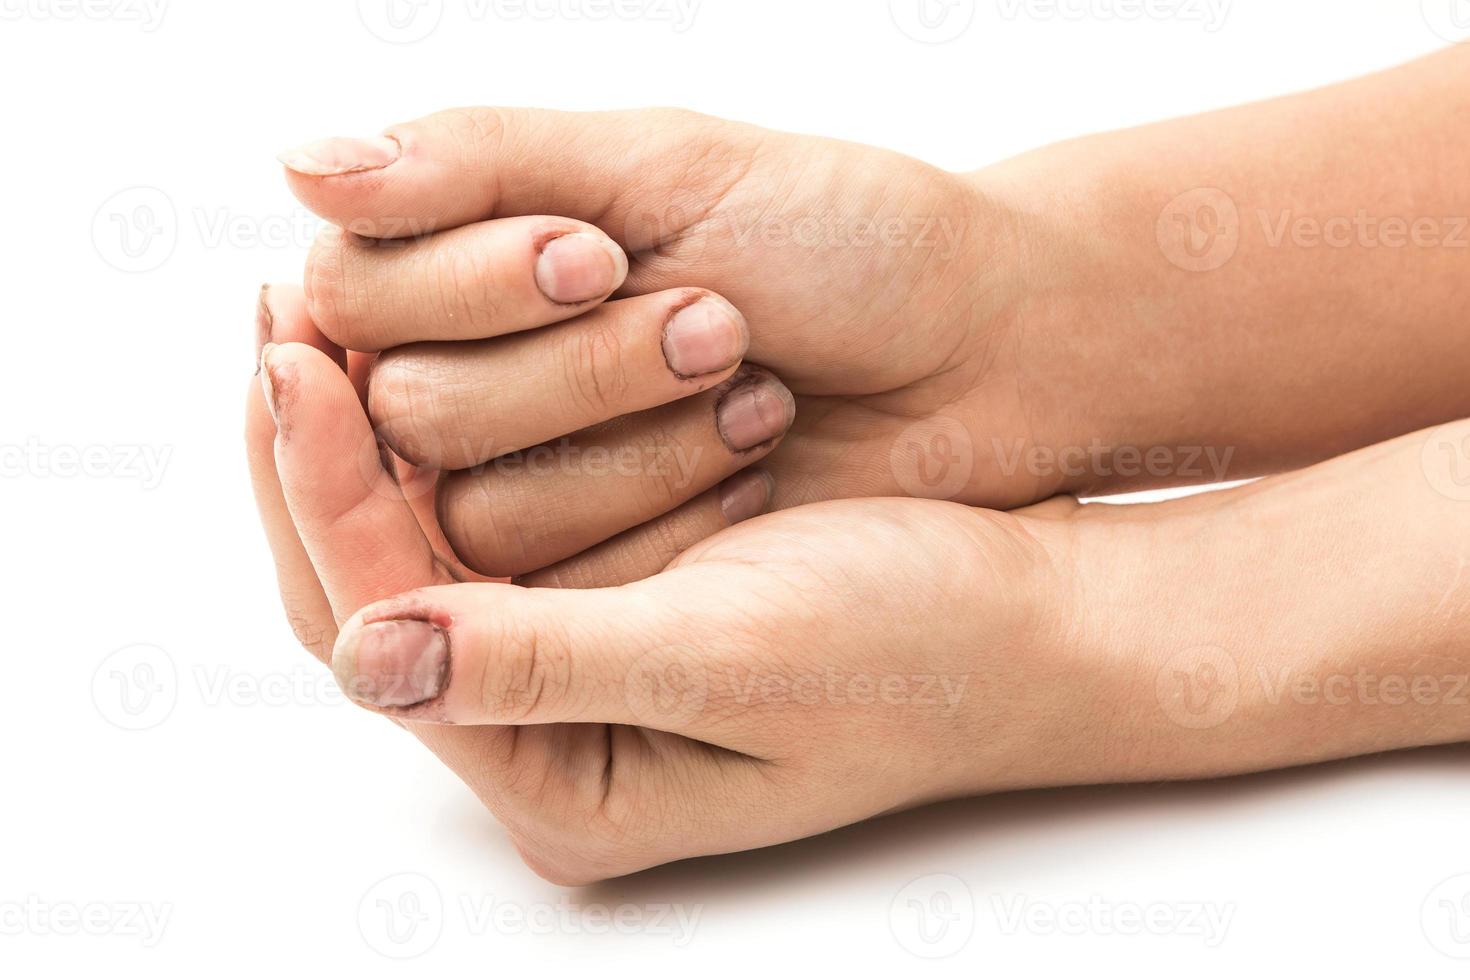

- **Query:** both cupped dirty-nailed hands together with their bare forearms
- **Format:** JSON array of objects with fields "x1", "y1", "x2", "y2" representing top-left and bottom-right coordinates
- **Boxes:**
[{"x1": 247, "y1": 49, "x2": 1470, "y2": 883}]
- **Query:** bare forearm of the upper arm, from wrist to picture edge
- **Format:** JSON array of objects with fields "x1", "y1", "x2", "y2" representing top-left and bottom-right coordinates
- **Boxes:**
[{"x1": 975, "y1": 48, "x2": 1470, "y2": 494}]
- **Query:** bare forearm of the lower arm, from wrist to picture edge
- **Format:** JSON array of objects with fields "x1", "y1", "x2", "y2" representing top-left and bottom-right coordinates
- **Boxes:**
[{"x1": 1072, "y1": 423, "x2": 1470, "y2": 779}]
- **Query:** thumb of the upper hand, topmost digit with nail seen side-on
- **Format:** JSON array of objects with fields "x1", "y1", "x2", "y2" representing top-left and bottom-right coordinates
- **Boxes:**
[{"x1": 281, "y1": 107, "x2": 772, "y2": 240}]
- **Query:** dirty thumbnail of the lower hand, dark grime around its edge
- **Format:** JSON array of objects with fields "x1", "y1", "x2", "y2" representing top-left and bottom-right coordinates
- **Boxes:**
[{"x1": 332, "y1": 620, "x2": 450, "y2": 708}]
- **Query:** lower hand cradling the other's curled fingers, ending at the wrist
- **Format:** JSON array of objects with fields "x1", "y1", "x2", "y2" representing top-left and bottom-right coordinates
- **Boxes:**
[{"x1": 248, "y1": 314, "x2": 1085, "y2": 882}]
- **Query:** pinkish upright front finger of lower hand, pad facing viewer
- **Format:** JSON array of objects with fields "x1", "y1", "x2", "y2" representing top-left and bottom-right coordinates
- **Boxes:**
[{"x1": 260, "y1": 337, "x2": 451, "y2": 621}]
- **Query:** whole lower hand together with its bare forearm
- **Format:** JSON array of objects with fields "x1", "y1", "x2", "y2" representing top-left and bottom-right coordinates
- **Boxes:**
[{"x1": 266, "y1": 315, "x2": 1470, "y2": 883}]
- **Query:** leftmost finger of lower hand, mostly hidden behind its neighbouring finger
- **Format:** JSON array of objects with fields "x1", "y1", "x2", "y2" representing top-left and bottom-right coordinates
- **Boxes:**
[{"x1": 245, "y1": 284, "x2": 351, "y2": 663}]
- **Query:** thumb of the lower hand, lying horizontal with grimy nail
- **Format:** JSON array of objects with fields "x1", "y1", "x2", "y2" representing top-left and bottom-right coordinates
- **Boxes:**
[{"x1": 332, "y1": 583, "x2": 720, "y2": 731}]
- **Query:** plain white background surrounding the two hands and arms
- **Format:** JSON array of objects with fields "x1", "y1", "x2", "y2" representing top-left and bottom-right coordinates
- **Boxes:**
[{"x1": 0, "y1": 0, "x2": 1470, "y2": 977}]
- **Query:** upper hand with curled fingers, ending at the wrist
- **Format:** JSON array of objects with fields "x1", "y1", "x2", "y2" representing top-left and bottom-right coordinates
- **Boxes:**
[{"x1": 282, "y1": 109, "x2": 1034, "y2": 574}]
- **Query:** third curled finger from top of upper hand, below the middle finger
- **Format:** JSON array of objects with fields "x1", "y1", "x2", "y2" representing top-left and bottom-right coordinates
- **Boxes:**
[{"x1": 438, "y1": 366, "x2": 795, "y2": 577}]
